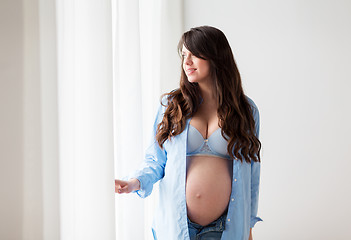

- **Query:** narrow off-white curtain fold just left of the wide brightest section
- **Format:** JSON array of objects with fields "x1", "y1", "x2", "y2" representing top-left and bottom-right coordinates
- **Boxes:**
[{"x1": 38, "y1": 0, "x2": 60, "y2": 240}]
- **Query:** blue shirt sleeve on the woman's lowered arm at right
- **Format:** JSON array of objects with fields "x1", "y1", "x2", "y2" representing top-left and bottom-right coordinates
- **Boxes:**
[{"x1": 250, "y1": 100, "x2": 262, "y2": 228}]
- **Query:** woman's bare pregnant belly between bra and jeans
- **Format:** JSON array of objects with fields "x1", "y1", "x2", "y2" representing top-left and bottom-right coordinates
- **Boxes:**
[{"x1": 186, "y1": 156, "x2": 233, "y2": 226}]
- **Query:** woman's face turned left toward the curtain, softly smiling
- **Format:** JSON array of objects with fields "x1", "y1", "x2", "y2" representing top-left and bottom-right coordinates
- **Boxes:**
[{"x1": 182, "y1": 46, "x2": 211, "y2": 83}]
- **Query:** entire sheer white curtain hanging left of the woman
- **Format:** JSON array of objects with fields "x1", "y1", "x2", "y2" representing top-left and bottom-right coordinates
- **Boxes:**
[{"x1": 11, "y1": 0, "x2": 182, "y2": 240}]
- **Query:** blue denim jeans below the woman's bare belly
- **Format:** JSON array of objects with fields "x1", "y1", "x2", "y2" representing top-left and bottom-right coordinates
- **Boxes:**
[{"x1": 188, "y1": 213, "x2": 227, "y2": 240}]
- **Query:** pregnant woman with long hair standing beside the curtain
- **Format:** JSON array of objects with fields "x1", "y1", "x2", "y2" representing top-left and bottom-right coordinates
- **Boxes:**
[{"x1": 115, "y1": 26, "x2": 262, "y2": 240}]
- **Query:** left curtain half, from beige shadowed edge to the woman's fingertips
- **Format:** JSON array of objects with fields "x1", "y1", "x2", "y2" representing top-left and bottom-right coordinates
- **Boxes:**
[{"x1": 13, "y1": 0, "x2": 115, "y2": 240}]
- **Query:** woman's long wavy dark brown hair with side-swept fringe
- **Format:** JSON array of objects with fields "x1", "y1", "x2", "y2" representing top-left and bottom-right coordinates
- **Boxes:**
[{"x1": 156, "y1": 26, "x2": 261, "y2": 163}]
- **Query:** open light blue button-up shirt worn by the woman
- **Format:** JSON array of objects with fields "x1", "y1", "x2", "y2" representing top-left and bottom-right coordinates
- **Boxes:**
[{"x1": 128, "y1": 94, "x2": 262, "y2": 240}]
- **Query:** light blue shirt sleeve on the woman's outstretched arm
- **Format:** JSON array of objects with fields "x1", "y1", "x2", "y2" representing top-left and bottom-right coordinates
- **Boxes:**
[{"x1": 128, "y1": 97, "x2": 167, "y2": 198}]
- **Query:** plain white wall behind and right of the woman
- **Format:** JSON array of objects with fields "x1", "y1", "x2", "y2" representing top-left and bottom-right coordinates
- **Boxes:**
[{"x1": 184, "y1": 0, "x2": 351, "y2": 240}]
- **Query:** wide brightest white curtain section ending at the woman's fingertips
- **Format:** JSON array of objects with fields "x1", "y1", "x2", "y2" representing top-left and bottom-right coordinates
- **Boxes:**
[{"x1": 56, "y1": 0, "x2": 115, "y2": 240}]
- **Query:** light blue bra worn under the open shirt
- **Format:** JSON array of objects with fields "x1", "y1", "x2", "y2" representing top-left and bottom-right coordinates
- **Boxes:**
[{"x1": 186, "y1": 124, "x2": 231, "y2": 159}]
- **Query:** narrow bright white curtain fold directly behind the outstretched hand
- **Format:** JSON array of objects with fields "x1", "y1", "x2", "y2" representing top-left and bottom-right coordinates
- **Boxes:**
[{"x1": 113, "y1": 0, "x2": 144, "y2": 240}]
